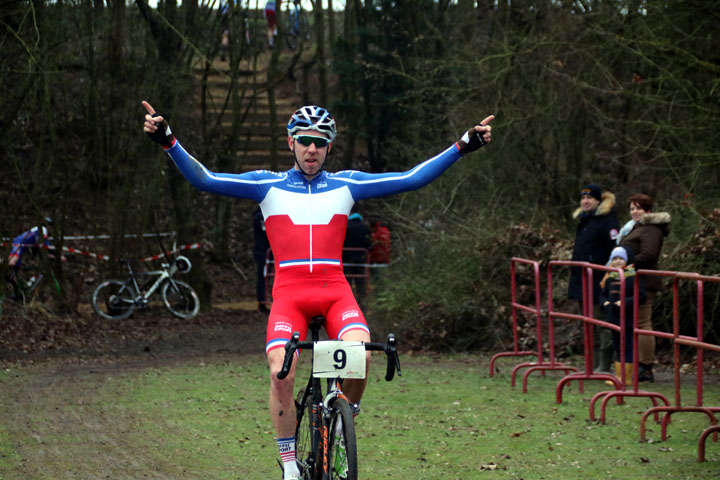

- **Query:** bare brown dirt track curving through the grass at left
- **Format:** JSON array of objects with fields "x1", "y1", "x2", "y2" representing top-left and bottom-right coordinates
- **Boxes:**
[{"x1": 0, "y1": 310, "x2": 266, "y2": 480}]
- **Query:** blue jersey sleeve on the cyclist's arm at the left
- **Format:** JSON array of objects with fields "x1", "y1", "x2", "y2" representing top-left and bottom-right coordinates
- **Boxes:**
[{"x1": 165, "y1": 141, "x2": 268, "y2": 202}]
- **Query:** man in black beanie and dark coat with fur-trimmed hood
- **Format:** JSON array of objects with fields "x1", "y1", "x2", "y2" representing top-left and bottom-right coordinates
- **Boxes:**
[{"x1": 568, "y1": 183, "x2": 620, "y2": 372}]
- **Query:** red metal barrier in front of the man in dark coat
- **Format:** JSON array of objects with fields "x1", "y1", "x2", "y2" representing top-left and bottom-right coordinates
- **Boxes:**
[{"x1": 548, "y1": 260, "x2": 625, "y2": 403}]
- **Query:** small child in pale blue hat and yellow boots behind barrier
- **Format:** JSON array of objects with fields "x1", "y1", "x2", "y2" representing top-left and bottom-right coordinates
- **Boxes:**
[{"x1": 600, "y1": 247, "x2": 646, "y2": 385}]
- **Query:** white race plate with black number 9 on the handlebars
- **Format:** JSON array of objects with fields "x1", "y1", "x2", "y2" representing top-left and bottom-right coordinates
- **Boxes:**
[{"x1": 313, "y1": 341, "x2": 365, "y2": 378}]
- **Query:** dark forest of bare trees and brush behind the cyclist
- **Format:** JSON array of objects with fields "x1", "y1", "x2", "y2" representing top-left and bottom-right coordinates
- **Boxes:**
[{"x1": 0, "y1": 0, "x2": 720, "y2": 349}]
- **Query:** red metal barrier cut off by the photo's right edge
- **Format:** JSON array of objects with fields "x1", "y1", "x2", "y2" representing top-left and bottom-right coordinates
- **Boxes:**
[{"x1": 635, "y1": 270, "x2": 720, "y2": 461}]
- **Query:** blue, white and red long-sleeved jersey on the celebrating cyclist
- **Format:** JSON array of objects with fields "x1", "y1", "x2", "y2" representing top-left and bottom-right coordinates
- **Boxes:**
[{"x1": 166, "y1": 142, "x2": 461, "y2": 282}]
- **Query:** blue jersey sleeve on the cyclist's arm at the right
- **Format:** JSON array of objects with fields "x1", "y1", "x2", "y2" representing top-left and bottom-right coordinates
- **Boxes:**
[{"x1": 334, "y1": 144, "x2": 461, "y2": 201}]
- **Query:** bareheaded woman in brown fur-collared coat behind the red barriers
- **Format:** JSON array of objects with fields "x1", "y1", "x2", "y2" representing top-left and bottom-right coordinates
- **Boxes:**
[{"x1": 618, "y1": 193, "x2": 670, "y2": 382}]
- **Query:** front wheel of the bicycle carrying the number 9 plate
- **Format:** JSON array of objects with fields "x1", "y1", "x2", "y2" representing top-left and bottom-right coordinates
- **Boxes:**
[{"x1": 327, "y1": 398, "x2": 357, "y2": 480}]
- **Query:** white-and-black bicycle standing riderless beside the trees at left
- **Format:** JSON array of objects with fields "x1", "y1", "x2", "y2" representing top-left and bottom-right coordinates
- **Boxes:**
[{"x1": 92, "y1": 255, "x2": 200, "y2": 320}]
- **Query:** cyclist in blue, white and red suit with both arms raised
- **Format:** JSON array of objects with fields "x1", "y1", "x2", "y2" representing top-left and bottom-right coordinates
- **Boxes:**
[{"x1": 143, "y1": 101, "x2": 494, "y2": 480}]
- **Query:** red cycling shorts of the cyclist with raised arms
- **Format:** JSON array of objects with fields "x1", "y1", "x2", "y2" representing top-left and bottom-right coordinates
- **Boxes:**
[{"x1": 265, "y1": 265, "x2": 370, "y2": 352}]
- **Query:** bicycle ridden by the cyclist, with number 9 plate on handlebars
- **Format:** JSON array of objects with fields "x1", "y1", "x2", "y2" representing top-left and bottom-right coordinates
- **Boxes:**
[{"x1": 277, "y1": 317, "x2": 402, "y2": 480}]
